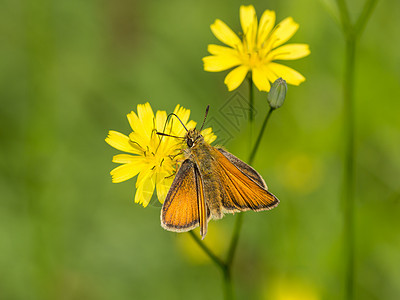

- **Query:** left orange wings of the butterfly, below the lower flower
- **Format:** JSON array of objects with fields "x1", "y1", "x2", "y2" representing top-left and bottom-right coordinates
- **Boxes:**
[{"x1": 161, "y1": 159, "x2": 210, "y2": 238}]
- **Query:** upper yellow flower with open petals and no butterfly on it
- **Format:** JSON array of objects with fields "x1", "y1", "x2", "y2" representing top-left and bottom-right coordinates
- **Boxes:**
[{"x1": 203, "y1": 5, "x2": 310, "y2": 92}]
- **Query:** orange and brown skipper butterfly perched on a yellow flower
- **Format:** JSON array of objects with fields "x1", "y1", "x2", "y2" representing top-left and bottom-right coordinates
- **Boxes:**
[{"x1": 158, "y1": 107, "x2": 279, "y2": 239}]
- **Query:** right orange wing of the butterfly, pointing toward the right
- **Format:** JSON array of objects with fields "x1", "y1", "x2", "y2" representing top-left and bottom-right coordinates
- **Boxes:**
[{"x1": 215, "y1": 149, "x2": 279, "y2": 212}]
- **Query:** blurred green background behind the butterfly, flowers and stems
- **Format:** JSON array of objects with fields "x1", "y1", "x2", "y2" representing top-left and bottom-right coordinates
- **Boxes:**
[{"x1": 0, "y1": 0, "x2": 400, "y2": 300}]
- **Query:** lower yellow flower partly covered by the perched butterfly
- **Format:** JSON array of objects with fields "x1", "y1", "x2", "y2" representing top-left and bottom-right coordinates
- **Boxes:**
[{"x1": 106, "y1": 103, "x2": 216, "y2": 207}]
